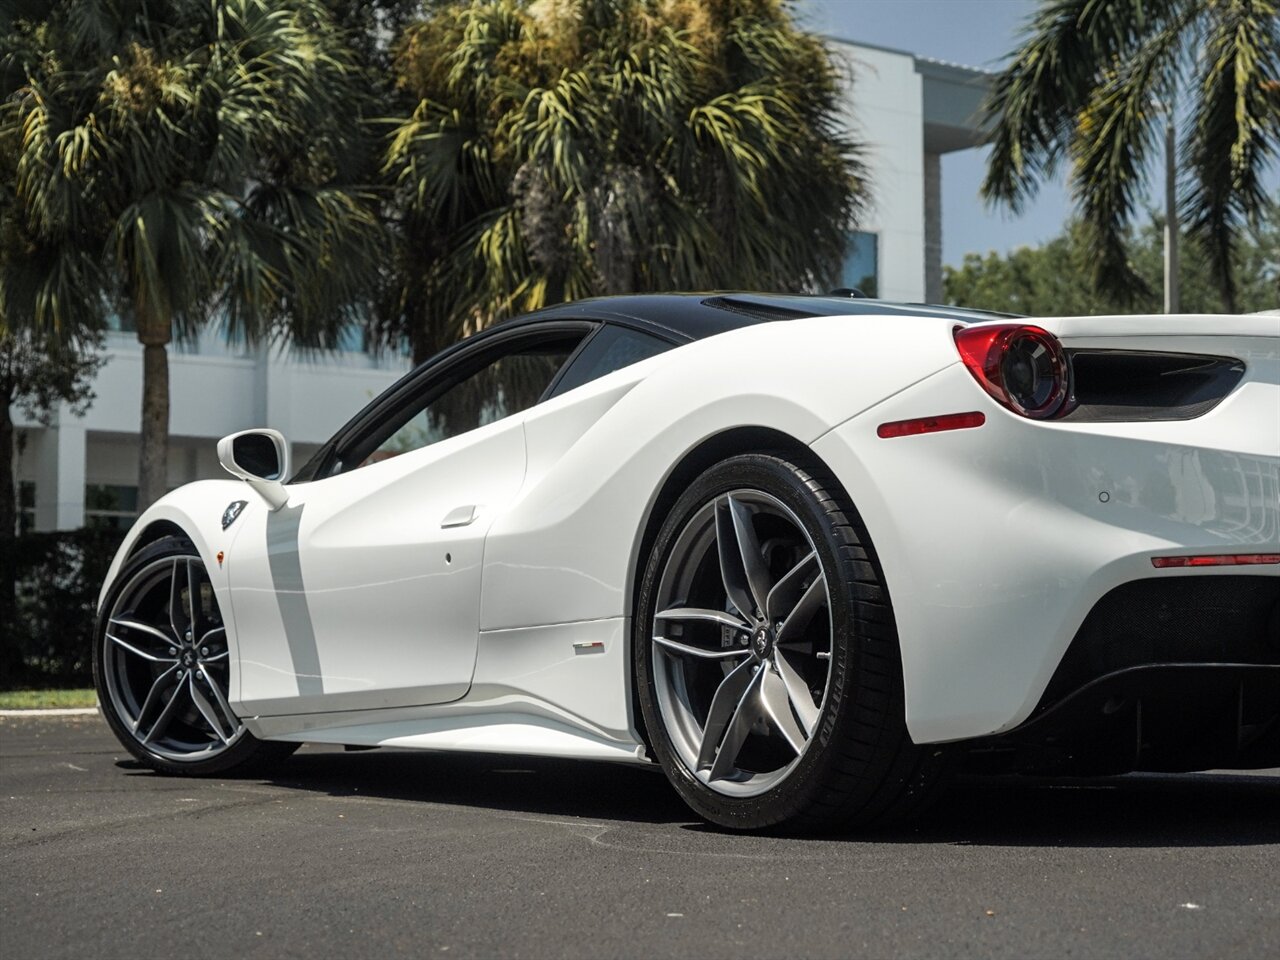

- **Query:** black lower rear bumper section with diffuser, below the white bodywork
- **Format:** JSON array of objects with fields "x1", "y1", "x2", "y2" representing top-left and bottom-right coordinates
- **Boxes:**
[{"x1": 970, "y1": 576, "x2": 1280, "y2": 774}]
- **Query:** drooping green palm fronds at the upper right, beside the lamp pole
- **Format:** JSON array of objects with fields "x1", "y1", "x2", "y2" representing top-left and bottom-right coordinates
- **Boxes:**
[{"x1": 982, "y1": 0, "x2": 1280, "y2": 310}]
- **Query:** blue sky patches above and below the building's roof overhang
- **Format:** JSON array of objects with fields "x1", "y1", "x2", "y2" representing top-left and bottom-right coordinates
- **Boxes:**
[{"x1": 797, "y1": 0, "x2": 1070, "y2": 265}]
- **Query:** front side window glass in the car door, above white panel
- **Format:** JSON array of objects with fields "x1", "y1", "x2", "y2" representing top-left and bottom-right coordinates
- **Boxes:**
[{"x1": 333, "y1": 333, "x2": 585, "y2": 474}]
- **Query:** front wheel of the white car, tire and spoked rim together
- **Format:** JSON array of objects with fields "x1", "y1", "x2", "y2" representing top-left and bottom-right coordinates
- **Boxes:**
[{"x1": 95, "y1": 538, "x2": 291, "y2": 773}]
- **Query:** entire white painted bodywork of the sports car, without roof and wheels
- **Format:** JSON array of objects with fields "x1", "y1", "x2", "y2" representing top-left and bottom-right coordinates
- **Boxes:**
[{"x1": 99, "y1": 309, "x2": 1280, "y2": 759}]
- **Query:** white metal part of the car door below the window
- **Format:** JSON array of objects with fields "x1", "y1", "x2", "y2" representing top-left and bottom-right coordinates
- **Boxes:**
[{"x1": 229, "y1": 421, "x2": 525, "y2": 716}]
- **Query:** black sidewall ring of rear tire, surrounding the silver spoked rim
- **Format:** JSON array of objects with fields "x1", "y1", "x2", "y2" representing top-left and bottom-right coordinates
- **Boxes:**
[{"x1": 632, "y1": 454, "x2": 858, "y2": 829}]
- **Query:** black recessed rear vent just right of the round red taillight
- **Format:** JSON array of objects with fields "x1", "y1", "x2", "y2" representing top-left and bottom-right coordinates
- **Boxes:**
[{"x1": 1061, "y1": 351, "x2": 1244, "y2": 422}]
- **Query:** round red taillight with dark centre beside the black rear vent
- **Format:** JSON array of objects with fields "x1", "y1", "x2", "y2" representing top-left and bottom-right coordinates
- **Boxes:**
[{"x1": 954, "y1": 324, "x2": 1068, "y2": 420}]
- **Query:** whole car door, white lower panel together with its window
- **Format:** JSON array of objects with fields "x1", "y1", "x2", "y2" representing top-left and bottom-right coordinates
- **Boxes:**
[{"x1": 227, "y1": 324, "x2": 590, "y2": 716}]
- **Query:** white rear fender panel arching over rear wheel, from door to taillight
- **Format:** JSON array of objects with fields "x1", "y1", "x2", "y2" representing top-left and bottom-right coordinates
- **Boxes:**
[{"x1": 481, "y1": 317, "x2": 956, "y2": 630}]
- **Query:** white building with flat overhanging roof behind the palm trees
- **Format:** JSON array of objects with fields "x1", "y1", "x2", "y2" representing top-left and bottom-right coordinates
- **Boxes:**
[{"x1": 13, "y1": 41, "x2": 989, "y2": 530}]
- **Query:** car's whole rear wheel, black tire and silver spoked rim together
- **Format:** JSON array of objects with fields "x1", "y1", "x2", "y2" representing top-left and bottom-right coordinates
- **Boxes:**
[{"x1": 634, "y1": 454, "x2": 946, "y2": 829}]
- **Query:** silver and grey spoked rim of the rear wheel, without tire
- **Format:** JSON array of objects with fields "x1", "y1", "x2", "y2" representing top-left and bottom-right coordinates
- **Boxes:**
[{"x1": 653, "y1": 489, "x2": 832, "y2": 796}]
